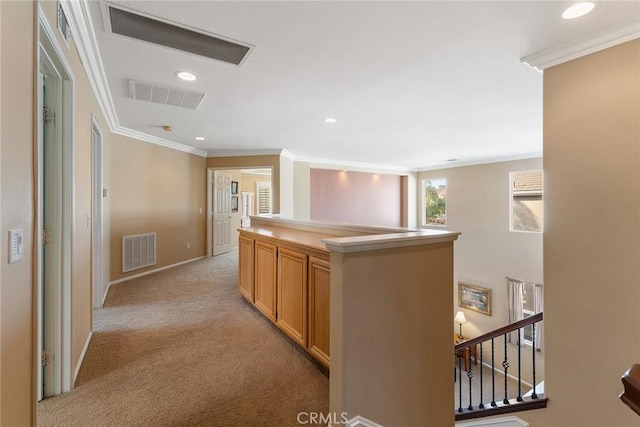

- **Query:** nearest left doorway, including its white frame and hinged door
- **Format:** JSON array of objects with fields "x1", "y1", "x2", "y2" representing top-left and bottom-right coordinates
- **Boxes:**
[{"x1": 35, "y1": 10, "x2": 74, "y2": 400}]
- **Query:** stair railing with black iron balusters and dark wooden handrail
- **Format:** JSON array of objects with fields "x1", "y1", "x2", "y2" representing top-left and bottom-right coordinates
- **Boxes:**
[{"x1": 454, "y1": 313, "x2": 547, "y2": 421}]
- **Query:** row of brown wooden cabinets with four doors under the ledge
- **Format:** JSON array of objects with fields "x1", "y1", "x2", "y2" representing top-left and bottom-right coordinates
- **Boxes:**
[{"x1": 238, "y1": 230, "x2": 331, "y2": 368}]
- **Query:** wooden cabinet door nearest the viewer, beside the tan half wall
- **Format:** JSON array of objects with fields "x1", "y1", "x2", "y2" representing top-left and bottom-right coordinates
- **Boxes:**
[{"x1": 308, "y1": 257, "x2": 331, "y2": 368}]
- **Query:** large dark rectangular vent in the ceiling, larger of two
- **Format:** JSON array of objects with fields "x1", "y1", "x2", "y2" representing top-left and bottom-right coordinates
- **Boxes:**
[{"x1": 105, "y1": 6, "x2": 253, "y2": 65}]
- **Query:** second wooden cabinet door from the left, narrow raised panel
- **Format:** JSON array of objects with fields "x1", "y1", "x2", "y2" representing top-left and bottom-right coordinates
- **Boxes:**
[{"x1": 254, "y1": 240, "x2": 276, "y2": 322}]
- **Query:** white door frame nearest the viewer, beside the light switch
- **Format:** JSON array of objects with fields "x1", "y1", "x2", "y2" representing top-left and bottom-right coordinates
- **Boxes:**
[{"x1": 34, "y1": 7, "x2": 75, "y2": 400}]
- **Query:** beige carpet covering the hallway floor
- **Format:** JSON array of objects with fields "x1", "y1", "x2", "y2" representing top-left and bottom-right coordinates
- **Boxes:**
[{"x1": 38, "y1": 251, "x2": 329, "y2": 427}]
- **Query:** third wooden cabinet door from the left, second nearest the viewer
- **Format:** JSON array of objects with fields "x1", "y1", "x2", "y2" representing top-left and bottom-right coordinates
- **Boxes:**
[{"x1": 276, "y1": 248, "x2": 307, "y2": 347}]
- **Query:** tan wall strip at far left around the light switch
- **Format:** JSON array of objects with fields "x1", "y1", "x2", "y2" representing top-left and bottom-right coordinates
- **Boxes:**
[{"x1": 0, "y1": 2, "x2": 35, "y2": 426}]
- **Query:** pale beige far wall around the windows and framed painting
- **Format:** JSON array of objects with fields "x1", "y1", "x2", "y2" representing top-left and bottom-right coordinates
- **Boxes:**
[{"x1": 418, "y1": 158, "x2": 544, "y2": 384}]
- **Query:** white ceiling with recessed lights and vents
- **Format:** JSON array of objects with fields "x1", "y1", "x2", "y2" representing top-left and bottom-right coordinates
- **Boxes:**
[{"x1": 88, "y1": 0, "x2": 640, "y2": 170}]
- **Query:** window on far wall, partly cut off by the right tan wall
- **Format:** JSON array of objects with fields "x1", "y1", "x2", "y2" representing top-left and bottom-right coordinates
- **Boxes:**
[{"x1": 509, "y1": 170, "x2": 543, "y2": 233}]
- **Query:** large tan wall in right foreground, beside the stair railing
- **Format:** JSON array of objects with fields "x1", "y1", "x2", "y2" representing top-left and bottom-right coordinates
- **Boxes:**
[{"x1": 522, "y1": 40, "x2": 640, "y2": 427}]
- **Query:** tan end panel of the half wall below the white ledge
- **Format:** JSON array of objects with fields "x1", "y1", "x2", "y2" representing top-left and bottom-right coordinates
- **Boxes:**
[{"x1": 329, "y1": 242, "x2": 454, "y2": 427}]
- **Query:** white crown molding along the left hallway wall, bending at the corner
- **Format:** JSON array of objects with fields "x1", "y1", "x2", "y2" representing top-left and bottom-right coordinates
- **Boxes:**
[{"x1": 60, "y1": 0, "x2": 207, "y2": 157}]
